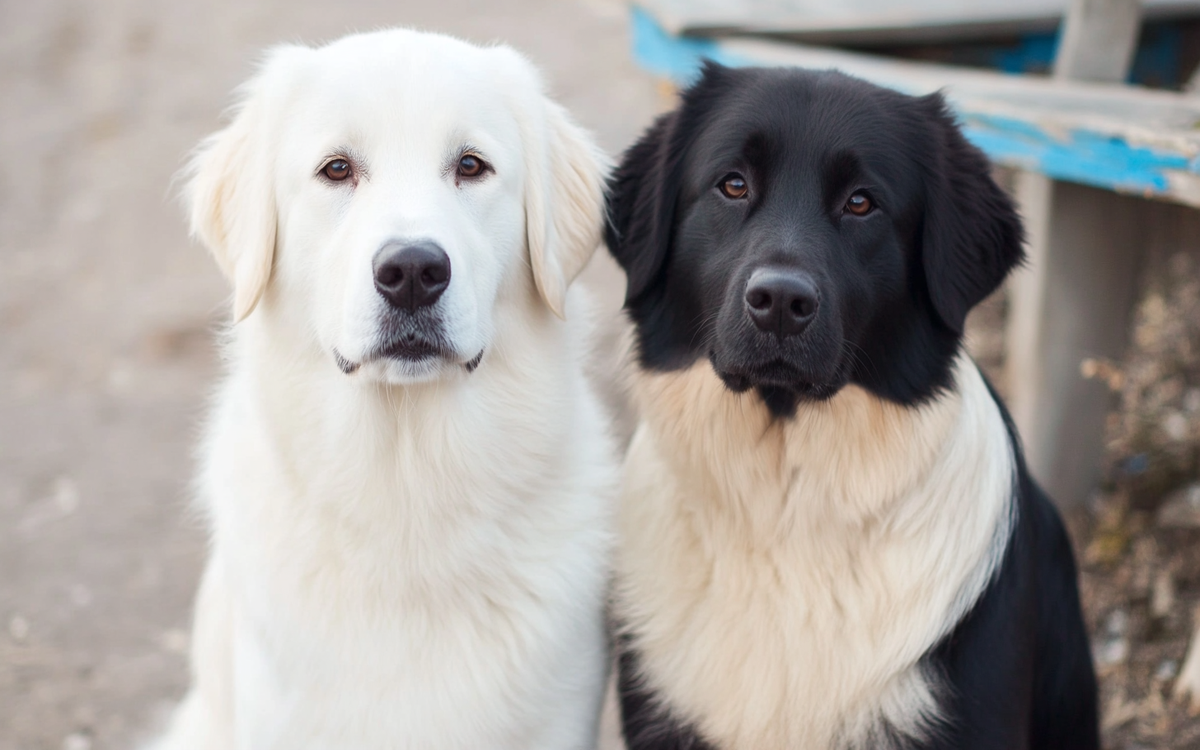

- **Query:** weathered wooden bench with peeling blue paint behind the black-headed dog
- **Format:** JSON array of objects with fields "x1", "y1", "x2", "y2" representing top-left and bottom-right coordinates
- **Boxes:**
[{"x1": 632, "y1": 0, "x2": 1200, "y2": 505}]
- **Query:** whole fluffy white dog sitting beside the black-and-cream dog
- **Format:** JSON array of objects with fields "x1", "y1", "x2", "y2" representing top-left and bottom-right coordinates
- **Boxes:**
[{"x1": 158, "y1": 30, "x2": 616, "y2": 750}]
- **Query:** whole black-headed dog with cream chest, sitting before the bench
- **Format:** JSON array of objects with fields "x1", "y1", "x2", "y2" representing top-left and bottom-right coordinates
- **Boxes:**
[{"x1": 607, "y1": 65, "x2": 1099, "y2": 750}]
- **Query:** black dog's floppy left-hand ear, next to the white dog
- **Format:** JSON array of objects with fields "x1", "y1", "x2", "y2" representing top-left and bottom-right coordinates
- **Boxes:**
[{"x1": 605, "y1": 62, "x2": 730, "y2": 305}]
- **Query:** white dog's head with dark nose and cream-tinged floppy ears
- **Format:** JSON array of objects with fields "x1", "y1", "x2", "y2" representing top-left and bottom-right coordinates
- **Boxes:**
[{"x1": 188, "y1": 30, "x2": 605, "y2": 383}]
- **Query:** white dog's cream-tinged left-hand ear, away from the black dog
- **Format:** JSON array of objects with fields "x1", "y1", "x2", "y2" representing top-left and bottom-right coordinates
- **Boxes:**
[{"x1": 185, "y1": 47, "x2": 310, "y2": 323}]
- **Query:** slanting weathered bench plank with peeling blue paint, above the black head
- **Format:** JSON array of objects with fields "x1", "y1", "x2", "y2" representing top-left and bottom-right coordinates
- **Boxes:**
[{"x1": 632, "y1": 8, "x2": 1200, "y2": 208}]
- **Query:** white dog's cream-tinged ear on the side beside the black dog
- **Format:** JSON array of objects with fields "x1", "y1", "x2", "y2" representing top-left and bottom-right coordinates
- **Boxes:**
[{"x1": 526, "y1": 101, "x2": 608, "y2": 318}]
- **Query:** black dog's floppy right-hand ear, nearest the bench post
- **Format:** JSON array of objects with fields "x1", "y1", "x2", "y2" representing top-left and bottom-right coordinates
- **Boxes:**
[{"x1": 919, "y1": 94, "x2": 1025, "y2": 334}]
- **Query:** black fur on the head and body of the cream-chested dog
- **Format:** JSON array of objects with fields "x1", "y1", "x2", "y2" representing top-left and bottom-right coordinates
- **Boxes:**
[{"x1": 606, "y1": 65, "x2": 1099, "y2": 750}]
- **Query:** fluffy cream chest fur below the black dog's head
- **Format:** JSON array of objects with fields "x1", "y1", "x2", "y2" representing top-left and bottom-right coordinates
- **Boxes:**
[{"x1": 617, "y1": 358, "x2": 1014, "y2": 750}]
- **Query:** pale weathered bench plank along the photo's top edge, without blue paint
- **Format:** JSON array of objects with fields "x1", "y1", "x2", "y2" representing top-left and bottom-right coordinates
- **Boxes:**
[{"x1": 638, "y1": 0, "x2": 1200, "y2": 44}]
